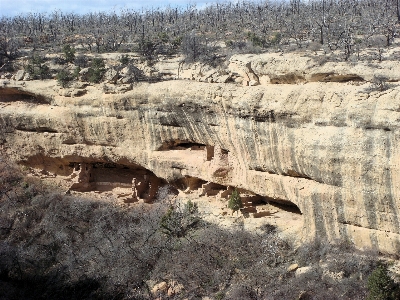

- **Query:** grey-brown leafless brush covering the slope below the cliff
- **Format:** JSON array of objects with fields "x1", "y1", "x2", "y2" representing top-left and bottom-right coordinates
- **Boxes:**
[{"x1": 0, "y1": 157, "x2": 388, "y2": 300}]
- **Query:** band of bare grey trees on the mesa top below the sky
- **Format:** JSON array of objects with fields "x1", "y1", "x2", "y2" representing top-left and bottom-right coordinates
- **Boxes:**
[{"x1": 0, "y1": 0, "x2": 399, "y2": 67}]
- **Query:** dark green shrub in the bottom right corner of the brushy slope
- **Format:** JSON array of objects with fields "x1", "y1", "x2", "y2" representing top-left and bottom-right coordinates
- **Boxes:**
[{"x1": 367, "y1": 264, "x2": 400, "y2": 300}]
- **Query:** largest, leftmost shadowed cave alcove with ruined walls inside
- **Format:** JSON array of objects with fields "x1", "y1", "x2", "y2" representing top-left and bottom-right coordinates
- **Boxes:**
[{"x1": 22, "y1": 156, "x2": 167, "y2": 203}]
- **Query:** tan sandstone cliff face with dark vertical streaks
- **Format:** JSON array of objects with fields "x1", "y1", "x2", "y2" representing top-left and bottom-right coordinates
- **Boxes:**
[{"x1": 0, "y1": 63, "x2": 400, "y2": 253}]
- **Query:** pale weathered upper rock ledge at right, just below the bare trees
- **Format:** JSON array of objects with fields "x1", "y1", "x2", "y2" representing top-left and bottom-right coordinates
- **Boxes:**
[{"x1": 150, "y1": 53, "x2": 400, "y2": 86}]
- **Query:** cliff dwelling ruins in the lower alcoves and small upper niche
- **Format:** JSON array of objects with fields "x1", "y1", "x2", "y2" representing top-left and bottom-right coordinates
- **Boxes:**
[{"x1": 18, "y1": 141, "x2": 301, "y2": 223}]
